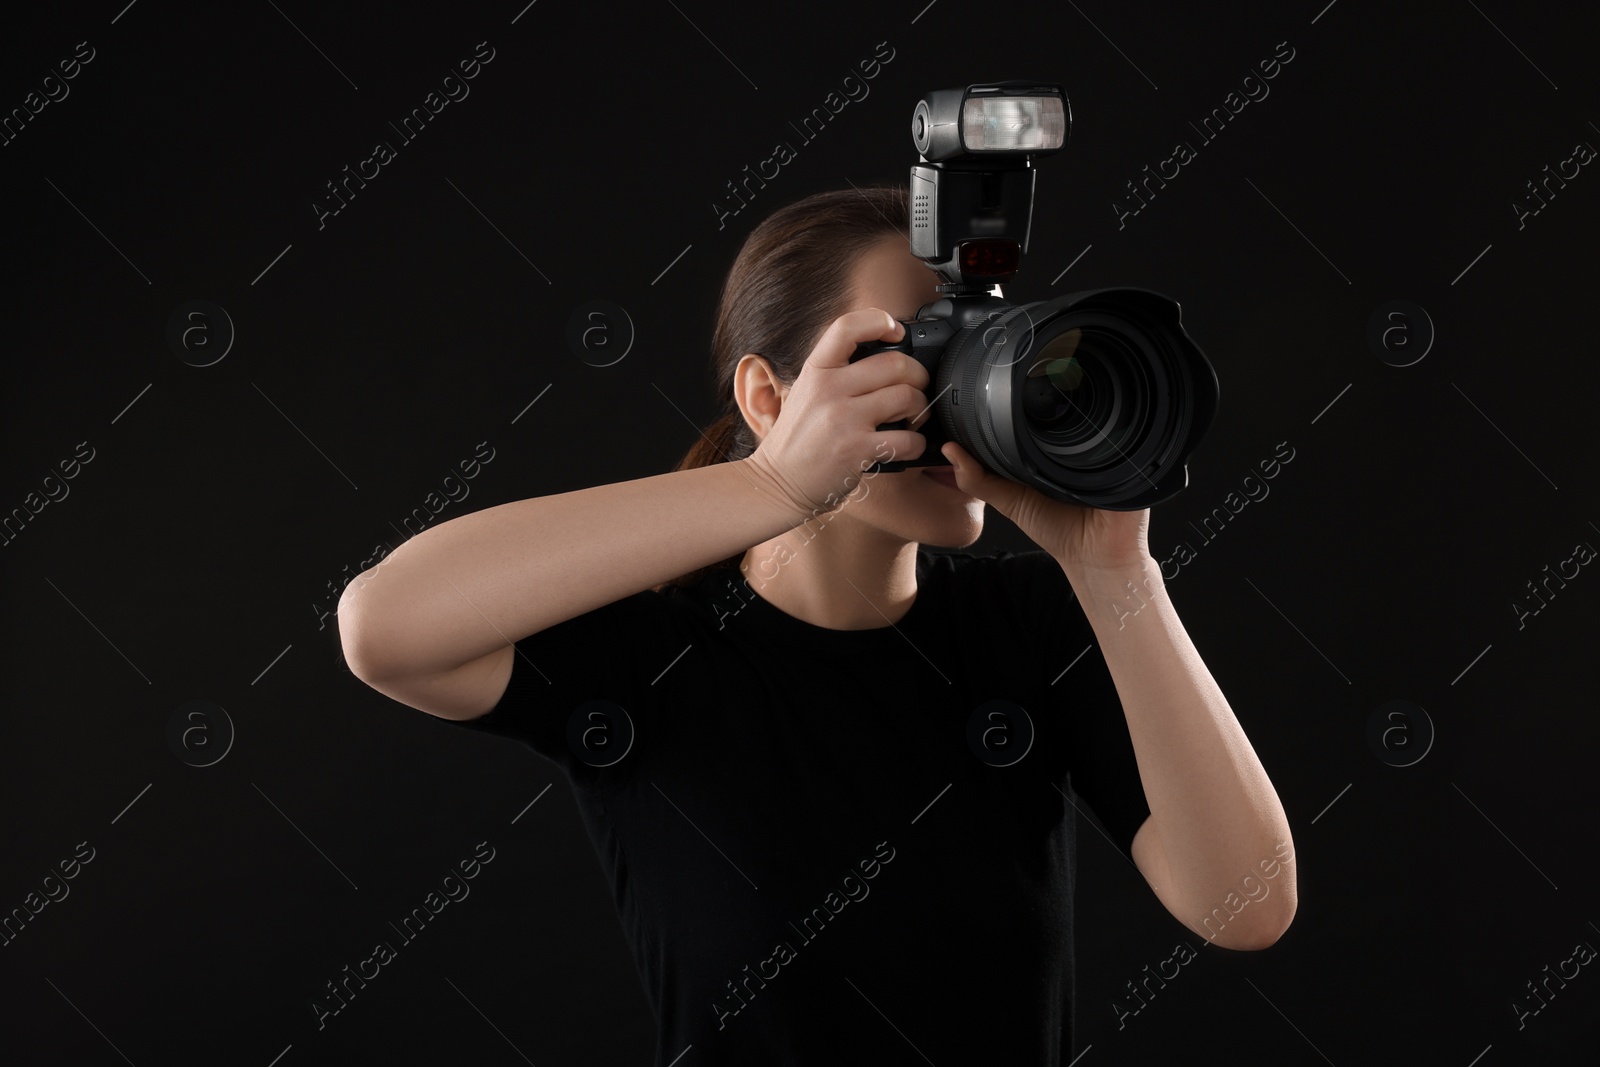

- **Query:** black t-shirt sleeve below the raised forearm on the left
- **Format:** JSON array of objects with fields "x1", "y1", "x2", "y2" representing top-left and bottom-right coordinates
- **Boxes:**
[{"x1": 445, "y1": 589, "x2": 688, "y2": 781}]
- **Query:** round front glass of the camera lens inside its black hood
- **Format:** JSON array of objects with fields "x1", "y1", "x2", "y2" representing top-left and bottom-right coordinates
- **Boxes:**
[{"x1": 1022, "y1": 326, "x2": 1150, "y2": 472}]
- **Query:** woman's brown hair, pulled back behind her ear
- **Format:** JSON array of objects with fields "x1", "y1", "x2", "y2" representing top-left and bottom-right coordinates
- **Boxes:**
[{"x1": 654, "y1": 184, "x2": 910, "y2": 592}]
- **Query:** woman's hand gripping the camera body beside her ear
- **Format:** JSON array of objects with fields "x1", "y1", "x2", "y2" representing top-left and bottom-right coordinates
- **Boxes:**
[{"x1": 746, "y1": 307, "x2": 928, "y2": 515}]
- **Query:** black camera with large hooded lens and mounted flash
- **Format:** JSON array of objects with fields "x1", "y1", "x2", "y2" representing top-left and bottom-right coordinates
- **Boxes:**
[{"x1": 850, "y1": 82, "x2": 1219, "y2": 510}]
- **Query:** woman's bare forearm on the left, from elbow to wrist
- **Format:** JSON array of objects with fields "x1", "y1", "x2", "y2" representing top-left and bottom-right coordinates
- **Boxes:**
[{"x1": 339, "y1": 459, "x2": 806, "y2": 677}]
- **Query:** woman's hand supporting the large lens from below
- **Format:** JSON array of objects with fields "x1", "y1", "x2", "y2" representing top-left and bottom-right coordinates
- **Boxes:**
[{"x1": 939, "y1": 442, "x2": 1150, "y2": 573}]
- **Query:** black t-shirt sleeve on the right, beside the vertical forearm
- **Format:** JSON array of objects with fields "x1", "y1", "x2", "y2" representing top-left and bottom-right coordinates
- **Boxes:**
[{"x1": 998, "y1": 550, "x2": 1150, "y2": 859}]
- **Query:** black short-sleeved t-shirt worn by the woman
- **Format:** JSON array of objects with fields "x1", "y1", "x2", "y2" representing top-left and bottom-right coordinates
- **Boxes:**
[{"x1": 451, "y1": 549, "x2": 1149, "y2": 1067}]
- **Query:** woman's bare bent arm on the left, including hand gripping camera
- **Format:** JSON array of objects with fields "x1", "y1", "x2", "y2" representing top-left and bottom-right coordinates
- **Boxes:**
[{"x1": 339, "y1": 307, "x2": 928, "y2": 717}]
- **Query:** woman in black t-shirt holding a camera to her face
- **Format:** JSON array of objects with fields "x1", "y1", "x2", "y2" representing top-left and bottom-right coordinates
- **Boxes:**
[{"x1": 339, "y1": 186, "x2": 1296, "y2": 1067}]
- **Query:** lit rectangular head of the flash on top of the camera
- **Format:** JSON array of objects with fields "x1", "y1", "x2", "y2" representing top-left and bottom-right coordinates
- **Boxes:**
[{"x1": 910, "y1": 82, "x2": 1072, "y2": 165}]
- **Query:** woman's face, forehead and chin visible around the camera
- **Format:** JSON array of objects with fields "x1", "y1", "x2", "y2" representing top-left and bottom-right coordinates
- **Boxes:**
[{"x1": 830, "y1": 234, "x2": 984, "y2": 549}]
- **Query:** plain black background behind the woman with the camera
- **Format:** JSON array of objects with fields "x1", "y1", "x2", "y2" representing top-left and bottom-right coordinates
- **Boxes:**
[{"x1": 0, "y1": 0, "x2": 1600, "y2": 1067}]
